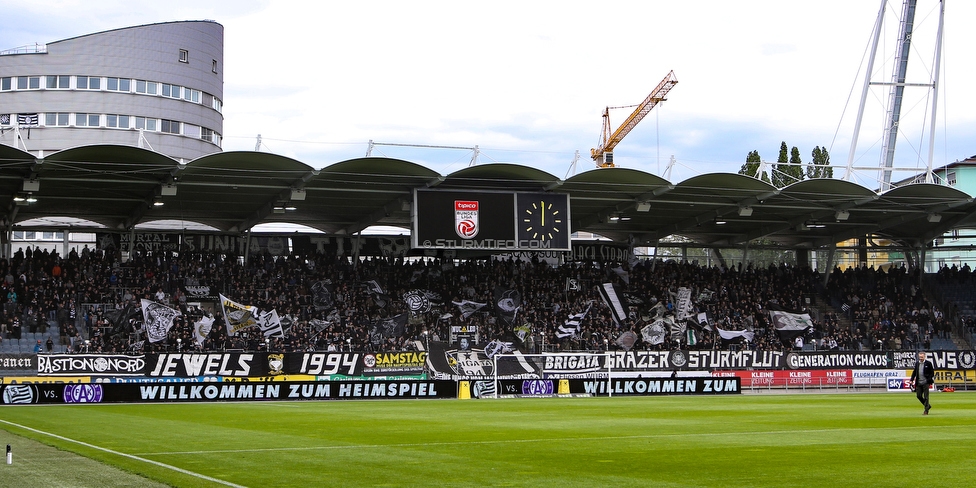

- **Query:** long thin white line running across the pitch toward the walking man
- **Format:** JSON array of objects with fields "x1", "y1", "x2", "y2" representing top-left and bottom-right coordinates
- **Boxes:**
[{"x1": 133, "y1": 426, "x2": 948, "y2": 456}]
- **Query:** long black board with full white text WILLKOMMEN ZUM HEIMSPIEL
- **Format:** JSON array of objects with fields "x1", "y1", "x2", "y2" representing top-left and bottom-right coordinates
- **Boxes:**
[{"x1": 0, "y1": 381, "x2": 457, "y2": 405}]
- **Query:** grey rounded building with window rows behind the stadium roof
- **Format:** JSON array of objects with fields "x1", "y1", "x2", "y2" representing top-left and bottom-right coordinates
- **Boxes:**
[{"x1": 0, "y1": 21, "x2": 224, "y2": 162}]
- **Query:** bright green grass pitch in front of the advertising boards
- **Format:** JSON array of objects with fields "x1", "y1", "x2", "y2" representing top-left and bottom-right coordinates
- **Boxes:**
[{"x1": 0, "y1": 392, "x2": 976, "y2": 487}]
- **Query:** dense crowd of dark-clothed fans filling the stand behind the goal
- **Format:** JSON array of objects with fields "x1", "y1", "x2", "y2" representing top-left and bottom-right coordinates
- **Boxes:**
[{"x1": 0, "y1": 247, "x2": 968, "y2": 352}]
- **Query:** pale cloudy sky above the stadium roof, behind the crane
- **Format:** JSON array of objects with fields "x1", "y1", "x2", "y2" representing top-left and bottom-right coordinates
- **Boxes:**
[{"x1": 0, "y1": 0, "x2": 976, "y2": 187}]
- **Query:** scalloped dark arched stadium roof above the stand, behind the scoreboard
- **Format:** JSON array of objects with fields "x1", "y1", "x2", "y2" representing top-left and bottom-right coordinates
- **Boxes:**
[{"x1": 0, "y1": 141, "x2": 976, "y2": 248}]
